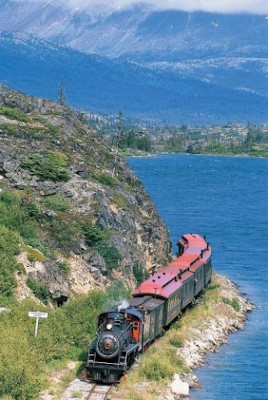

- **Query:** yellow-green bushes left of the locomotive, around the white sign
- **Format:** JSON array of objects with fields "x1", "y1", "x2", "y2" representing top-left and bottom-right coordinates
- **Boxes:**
[{"x1": 0, "y1": 283, "x2": 130, "y2": 400}]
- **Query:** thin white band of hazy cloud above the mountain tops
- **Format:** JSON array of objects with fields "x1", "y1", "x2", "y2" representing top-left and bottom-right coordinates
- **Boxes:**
[{"x1": 63, "y1": 0, "x2": 268, "y2": 14}]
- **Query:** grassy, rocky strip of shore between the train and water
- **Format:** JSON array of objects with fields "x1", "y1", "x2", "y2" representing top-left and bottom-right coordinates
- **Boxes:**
[{"x1": 112, "y1": 272, "x2": 255, "y2": 400}]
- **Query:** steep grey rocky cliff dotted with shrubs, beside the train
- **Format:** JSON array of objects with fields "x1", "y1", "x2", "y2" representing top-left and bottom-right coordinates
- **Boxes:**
[{"x1": 0, "y1": 86, "x2": 170, "y2": 304}]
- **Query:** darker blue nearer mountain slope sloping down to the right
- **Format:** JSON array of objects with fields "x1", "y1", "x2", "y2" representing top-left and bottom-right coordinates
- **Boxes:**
[{"x1": 0, "y1": 33, "x2": 268, "y2": 124}]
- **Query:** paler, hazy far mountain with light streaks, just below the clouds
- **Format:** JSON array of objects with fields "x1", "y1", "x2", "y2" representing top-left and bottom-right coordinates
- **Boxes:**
[{"x1": 0, "y1": 0, "x2": 268, "y2": 61}]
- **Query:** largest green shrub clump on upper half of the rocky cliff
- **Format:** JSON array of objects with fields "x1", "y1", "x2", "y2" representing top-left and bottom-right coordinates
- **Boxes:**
[{"x1": 21, "y1": 151, "x2": 70, "y2": 181}]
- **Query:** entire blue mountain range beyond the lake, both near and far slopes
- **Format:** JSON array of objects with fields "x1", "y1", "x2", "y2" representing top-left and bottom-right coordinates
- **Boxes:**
[{"x1": 0, "y1": 0, "x2": 268, "y2": 124}]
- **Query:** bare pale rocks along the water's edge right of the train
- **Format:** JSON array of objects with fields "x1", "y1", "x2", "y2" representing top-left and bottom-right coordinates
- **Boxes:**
[{"x1": 165, "y1": 275, "x2": 254, "y2": 400}]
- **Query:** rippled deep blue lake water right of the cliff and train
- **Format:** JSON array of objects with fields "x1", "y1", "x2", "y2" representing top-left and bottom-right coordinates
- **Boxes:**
[{"x1": 127, "y1": 155, "x2": 268, "y2": 400}]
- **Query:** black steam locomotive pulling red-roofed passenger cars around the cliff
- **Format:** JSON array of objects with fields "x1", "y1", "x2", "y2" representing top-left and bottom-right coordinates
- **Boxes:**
[{"x1": 85, "y1": 233, "x2": 212, "y2": 384}]
